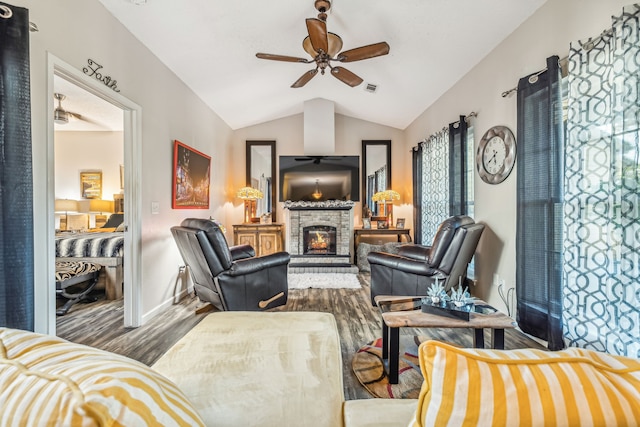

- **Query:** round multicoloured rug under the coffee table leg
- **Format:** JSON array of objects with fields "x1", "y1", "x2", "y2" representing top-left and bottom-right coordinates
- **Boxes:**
[{"x1": 351, "y1": 335, "x2": 423, "y2": 399}]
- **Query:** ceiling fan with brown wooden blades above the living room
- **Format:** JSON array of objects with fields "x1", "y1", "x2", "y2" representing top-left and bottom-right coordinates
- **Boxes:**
[{"x1": 256, "y1": 0, "x2": 389, "y2": 88}]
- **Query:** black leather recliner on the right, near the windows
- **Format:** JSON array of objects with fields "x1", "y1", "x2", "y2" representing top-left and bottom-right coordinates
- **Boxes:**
[{"x1": 367, "y1": 215, "x2": 484, "y2": 305}]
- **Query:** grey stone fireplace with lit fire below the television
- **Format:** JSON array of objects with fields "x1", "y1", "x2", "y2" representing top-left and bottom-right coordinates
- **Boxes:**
[{"x1": 284, "y1": 201, "x2": 358, "y2": 273}]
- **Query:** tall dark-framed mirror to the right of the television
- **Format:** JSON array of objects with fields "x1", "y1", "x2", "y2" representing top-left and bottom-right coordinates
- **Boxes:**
[{"x1": 362, "y1": 140, "x2": 391, "y2": 217}]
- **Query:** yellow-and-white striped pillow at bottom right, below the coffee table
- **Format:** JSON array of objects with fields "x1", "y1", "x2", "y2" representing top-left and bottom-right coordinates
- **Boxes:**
[{"x1": 410, "y1": 341, "x2": 640, "y2": 427}]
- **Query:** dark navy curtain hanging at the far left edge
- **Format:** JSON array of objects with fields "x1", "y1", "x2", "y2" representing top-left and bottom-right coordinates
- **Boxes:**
[{"x1": 0, "y1": 2, "x2": 34, "y2": 330}]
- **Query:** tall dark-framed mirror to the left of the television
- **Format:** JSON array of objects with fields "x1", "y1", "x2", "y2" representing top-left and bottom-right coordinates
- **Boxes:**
[{"x1": 245, "y1": 141, "x2": 277, "y2": 222}]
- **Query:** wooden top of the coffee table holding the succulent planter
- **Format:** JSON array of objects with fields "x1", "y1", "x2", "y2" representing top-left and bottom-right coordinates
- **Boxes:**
[{"x1": 374, "y1": 295, "x2": 516, "y2": 329}]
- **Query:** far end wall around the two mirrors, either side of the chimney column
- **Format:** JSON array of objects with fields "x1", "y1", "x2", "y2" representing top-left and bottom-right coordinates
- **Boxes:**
[{"x1": 232, "y1": 114, "x2": 411, "y2": 227}]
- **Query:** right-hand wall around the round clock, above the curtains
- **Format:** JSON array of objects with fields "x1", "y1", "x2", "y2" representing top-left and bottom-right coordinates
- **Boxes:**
[{"x1": 405, "y1": 0, "x2": 631, "y2": 309}]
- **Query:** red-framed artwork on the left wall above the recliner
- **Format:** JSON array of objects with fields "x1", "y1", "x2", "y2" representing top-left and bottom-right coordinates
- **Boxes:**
[{"x1": 171, "y1": 140, "x2": 211, "y2": 209}]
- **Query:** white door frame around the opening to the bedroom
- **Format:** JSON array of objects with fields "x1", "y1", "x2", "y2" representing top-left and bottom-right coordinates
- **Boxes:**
[{"x1": 40, "y1": 53, "x2": 142, "y2": 335}]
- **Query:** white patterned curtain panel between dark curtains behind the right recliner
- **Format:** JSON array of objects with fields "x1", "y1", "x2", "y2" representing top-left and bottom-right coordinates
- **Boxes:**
[{"x1": 420, "y1": 128, "x2": 449, "y2": 244}]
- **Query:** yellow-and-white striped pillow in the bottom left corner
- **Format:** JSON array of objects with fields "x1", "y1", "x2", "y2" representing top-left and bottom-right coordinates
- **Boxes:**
[{"x1": 0, "y1": 328, "x2": 204, "y2": 426}]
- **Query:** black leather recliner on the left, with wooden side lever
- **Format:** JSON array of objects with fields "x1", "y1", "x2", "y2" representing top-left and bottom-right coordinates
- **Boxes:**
[{"x1": 171, "y1": 218, "x2": 290, "y2": 311}]
